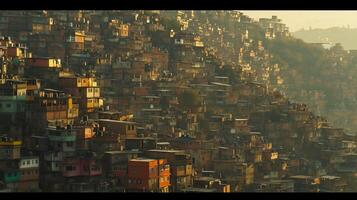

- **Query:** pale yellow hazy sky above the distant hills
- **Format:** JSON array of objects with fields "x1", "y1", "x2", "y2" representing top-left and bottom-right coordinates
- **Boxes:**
[{"x1": 242, "y1": 10, "x2": 357, "y2": 32}]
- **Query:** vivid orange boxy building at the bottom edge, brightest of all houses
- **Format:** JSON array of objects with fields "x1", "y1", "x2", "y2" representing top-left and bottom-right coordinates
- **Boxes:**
[{"x1": 127, "y1": 158, "x2": 170, "y2": 192}]
